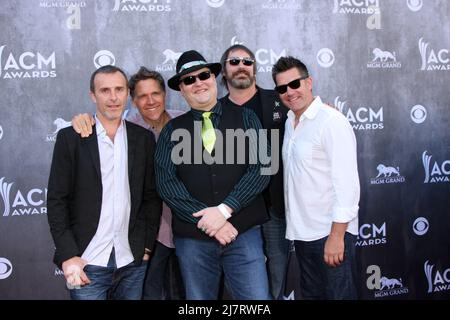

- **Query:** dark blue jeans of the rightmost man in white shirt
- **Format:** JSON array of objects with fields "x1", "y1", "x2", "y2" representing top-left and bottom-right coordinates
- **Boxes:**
[{"x1": 294, "y1": 232, "x2": 357, "y2": 300}]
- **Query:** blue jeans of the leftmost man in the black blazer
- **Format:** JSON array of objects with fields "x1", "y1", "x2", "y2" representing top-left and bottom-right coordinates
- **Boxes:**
[{"x1": 70, "y1": 249, "x2": 147, "y2": 300}]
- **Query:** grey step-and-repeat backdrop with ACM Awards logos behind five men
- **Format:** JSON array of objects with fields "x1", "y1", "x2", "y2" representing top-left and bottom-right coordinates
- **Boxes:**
[{"x1": 0, "y1": 0, "x2": 450, "y2": 299}]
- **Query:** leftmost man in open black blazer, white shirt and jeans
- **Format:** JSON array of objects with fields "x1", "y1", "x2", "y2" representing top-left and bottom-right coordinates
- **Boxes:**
[{"x1": 47, "y1": 66, "x2": 161, "y2": 299}]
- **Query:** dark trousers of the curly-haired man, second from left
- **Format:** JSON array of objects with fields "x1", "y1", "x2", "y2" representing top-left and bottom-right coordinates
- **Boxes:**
[{"x1": 142, "y1": 241, "x2": 185, "y2": 300}]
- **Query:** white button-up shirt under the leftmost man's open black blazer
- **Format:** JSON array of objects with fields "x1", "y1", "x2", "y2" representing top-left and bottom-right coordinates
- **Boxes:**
[{"x1": 81, "y1": 117, "x2": 134, "y2": 268}]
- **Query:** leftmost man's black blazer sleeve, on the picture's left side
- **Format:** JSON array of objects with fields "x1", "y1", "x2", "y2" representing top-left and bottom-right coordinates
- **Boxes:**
[{"x1": 47, "y1": 130, "x2": 80, "y2": 268}]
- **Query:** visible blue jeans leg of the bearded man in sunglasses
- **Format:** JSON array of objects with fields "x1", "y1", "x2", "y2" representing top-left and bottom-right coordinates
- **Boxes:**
[{"x1": 262, "y1": 209, "x2": 291, "y2": 300}]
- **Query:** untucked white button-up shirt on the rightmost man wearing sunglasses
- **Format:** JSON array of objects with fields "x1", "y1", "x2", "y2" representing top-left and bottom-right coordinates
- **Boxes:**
[{"x1": 283, "y1": 97, "x2": 360, "y2": 241}]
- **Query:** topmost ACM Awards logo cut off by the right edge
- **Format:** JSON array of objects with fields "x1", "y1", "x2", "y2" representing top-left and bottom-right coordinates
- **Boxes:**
[{"x1": 419, "y1": 38, "x2": 450, "y2": 71}]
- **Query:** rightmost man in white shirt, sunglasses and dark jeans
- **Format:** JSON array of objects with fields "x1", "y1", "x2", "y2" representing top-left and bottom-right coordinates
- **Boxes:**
[{"x1": 272, "y1": 57, "x2": 360, "y2": 299}]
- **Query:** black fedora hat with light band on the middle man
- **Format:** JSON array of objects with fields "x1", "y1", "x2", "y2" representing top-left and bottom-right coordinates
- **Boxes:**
[{"x1": 167, "y1": 50, "x2": 222, "y2": 91}]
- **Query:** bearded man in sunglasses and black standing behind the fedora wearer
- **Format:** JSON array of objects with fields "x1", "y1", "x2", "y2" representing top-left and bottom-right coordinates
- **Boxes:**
[{"x1": 220, "y1": 44, "x2": 290, "y2": 299}]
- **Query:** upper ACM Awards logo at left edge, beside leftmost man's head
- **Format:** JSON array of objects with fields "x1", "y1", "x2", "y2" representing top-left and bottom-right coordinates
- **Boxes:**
[{"x1": 0, "y1": 45, "x2": 56, "y2": 79}]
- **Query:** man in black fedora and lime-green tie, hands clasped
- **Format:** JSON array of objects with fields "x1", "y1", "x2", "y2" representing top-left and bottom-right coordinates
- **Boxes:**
[{"x1": 155, "y1": 50, "x2": 270, "y2": 299}]
